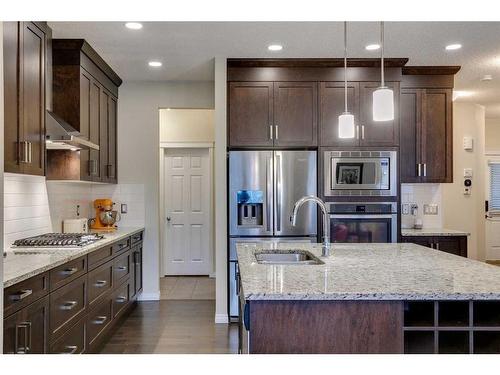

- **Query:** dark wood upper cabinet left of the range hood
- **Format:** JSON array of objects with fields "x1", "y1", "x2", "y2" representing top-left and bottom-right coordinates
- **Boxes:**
[{"x1": 3, "y1": 22, "x2": 52, "y2": 176}]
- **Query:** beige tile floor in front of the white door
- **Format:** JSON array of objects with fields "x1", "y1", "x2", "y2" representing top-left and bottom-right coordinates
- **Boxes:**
[{"x1": 160, "y1": 276, "x2": 215, "y2": 300}]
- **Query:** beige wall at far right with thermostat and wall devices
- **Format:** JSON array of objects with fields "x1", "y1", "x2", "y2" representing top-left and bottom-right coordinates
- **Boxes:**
[{"x1": 441, "y1": 102, "x2": 486, "y2": 260}]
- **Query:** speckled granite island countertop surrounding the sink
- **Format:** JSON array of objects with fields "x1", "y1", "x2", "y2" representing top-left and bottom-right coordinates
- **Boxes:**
[{"x1": 237, "y1": 243, "x2": 500, "y2": 300}]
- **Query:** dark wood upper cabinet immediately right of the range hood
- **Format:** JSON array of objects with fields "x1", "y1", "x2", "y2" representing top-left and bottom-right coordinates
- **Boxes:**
[{"x1": 47, "y1": 39, "x2": 122, "y2": 183}]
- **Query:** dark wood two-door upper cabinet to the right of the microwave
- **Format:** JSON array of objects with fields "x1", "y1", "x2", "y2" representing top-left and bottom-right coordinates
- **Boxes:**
[{"x1": 400, "y1": 88, "x2": 453, "y2": 183}]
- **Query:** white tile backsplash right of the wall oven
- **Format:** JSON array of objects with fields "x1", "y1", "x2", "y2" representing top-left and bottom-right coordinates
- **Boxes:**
[{"x1": 401, "y1": 184, "x2": 443, "y2": 228}]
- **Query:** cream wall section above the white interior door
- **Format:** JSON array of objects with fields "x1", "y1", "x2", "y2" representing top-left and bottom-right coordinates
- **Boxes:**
[{"x1": 160, "y1": 109, "x2": 215, "y2": 143}]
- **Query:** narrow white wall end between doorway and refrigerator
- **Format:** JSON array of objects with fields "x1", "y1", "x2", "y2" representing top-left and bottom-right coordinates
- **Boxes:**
[{"x1": 214, "y1": 57, "x2": 229, "y2": 323}]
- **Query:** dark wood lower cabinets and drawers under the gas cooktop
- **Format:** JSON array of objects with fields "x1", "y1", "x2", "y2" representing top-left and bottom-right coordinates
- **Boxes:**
[{"x1": 3, "y1": 233, "x2": 143, "y2": 354}]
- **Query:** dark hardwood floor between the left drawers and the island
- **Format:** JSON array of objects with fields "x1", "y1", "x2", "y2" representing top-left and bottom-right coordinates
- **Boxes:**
[{"x1": 101, "y1": 300, "x2": 238, "y2": 354}]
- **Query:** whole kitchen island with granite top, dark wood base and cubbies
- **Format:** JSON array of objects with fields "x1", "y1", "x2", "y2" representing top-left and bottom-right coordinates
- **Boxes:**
[{"x1": 237, "y1": 243, "x2": 500, "y2": 353}]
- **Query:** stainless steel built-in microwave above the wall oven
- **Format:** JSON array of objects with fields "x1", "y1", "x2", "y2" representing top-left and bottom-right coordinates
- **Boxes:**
[{"x1": 324, "y1": 150, "x2": 398, "y2": 197}]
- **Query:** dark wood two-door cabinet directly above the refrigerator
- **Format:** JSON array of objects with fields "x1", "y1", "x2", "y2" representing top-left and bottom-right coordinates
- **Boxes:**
[{"x1": 229, "y1": 82, "x2": 318, "y2": 147}]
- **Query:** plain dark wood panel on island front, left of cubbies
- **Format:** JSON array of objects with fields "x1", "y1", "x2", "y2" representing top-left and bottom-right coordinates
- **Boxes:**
[{"x1": 249, "y1": 301, "x2": 403, "y2": 354}]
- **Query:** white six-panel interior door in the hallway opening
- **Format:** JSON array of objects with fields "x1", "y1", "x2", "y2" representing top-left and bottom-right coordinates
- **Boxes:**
[{"x1": 164, "y1": 149, "x2": 211, "y2": 275}]
